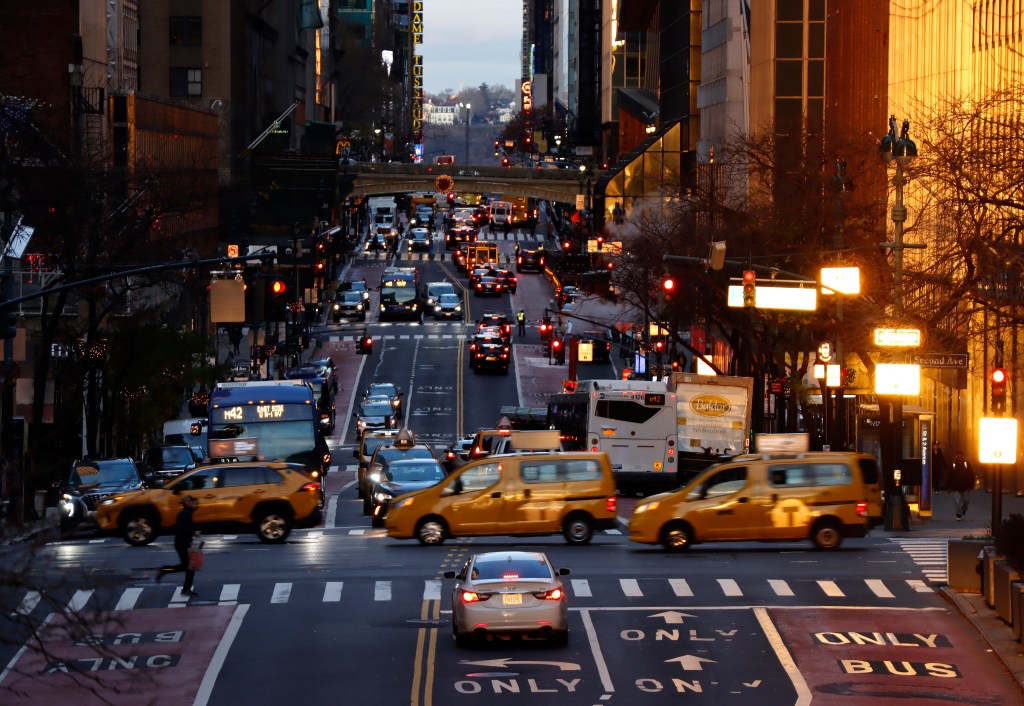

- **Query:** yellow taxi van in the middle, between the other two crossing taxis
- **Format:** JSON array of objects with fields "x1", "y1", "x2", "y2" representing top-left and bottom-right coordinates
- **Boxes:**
[{"x1": 385, "y1": 452, "x2": 616, "y2": 545}]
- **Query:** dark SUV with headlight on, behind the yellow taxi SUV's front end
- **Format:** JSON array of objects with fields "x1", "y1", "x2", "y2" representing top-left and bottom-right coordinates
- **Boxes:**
[{"x1": 58, "y1": 458, "x2": 145, "y2": 532}]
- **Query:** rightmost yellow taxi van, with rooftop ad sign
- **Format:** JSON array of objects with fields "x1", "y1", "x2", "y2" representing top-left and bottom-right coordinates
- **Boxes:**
[{"x1": 629, "y1": 434, "x2": 882, "y2": 551}]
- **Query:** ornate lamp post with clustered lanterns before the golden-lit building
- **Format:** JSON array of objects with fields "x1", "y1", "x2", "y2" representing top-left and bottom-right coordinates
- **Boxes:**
[{"x1": 879, "y1": 115, "x2": 925, "y2": 530}]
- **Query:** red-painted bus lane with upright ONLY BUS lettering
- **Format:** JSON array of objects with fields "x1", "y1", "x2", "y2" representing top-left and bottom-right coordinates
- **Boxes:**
[{"x1": 767, "y1": 608, "x2": 1021, "y2": 706}]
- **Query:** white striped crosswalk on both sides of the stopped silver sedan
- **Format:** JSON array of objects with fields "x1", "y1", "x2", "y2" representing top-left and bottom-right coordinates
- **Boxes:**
[{"x1": 12, "y1": 578, "x2": 934, "y2": 616}]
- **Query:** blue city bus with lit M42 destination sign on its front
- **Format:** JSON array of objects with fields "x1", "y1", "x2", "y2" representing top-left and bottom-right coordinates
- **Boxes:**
[{"x1": 201, "y1": 380, "x2": 331, "y2": 477}]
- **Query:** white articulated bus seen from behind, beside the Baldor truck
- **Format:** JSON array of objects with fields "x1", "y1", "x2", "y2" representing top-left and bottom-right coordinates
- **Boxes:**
[{"x1": 548, "y1": 380, "x2": 679, "y2": 494}]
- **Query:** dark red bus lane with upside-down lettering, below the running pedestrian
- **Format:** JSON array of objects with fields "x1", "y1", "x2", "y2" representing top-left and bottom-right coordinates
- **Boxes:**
[{"x1": 0, "y1": 606, "x2": 245, "y2": 706}]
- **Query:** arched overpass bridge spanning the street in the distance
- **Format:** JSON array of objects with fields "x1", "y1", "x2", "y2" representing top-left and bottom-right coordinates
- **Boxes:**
[{"x1": 339, "y1": 162, "x2": 604, "y2": 204}]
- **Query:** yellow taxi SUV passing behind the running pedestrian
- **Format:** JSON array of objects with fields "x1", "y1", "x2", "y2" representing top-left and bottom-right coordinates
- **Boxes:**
[{"x1": 96, "y1": 462, "x2": 322, "y2": 546}]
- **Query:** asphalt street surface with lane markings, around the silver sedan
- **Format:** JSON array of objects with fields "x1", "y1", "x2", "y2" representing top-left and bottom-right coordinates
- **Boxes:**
[{"x1": 0, "y1": 228, "x2": 1022, "y2": 706}]
